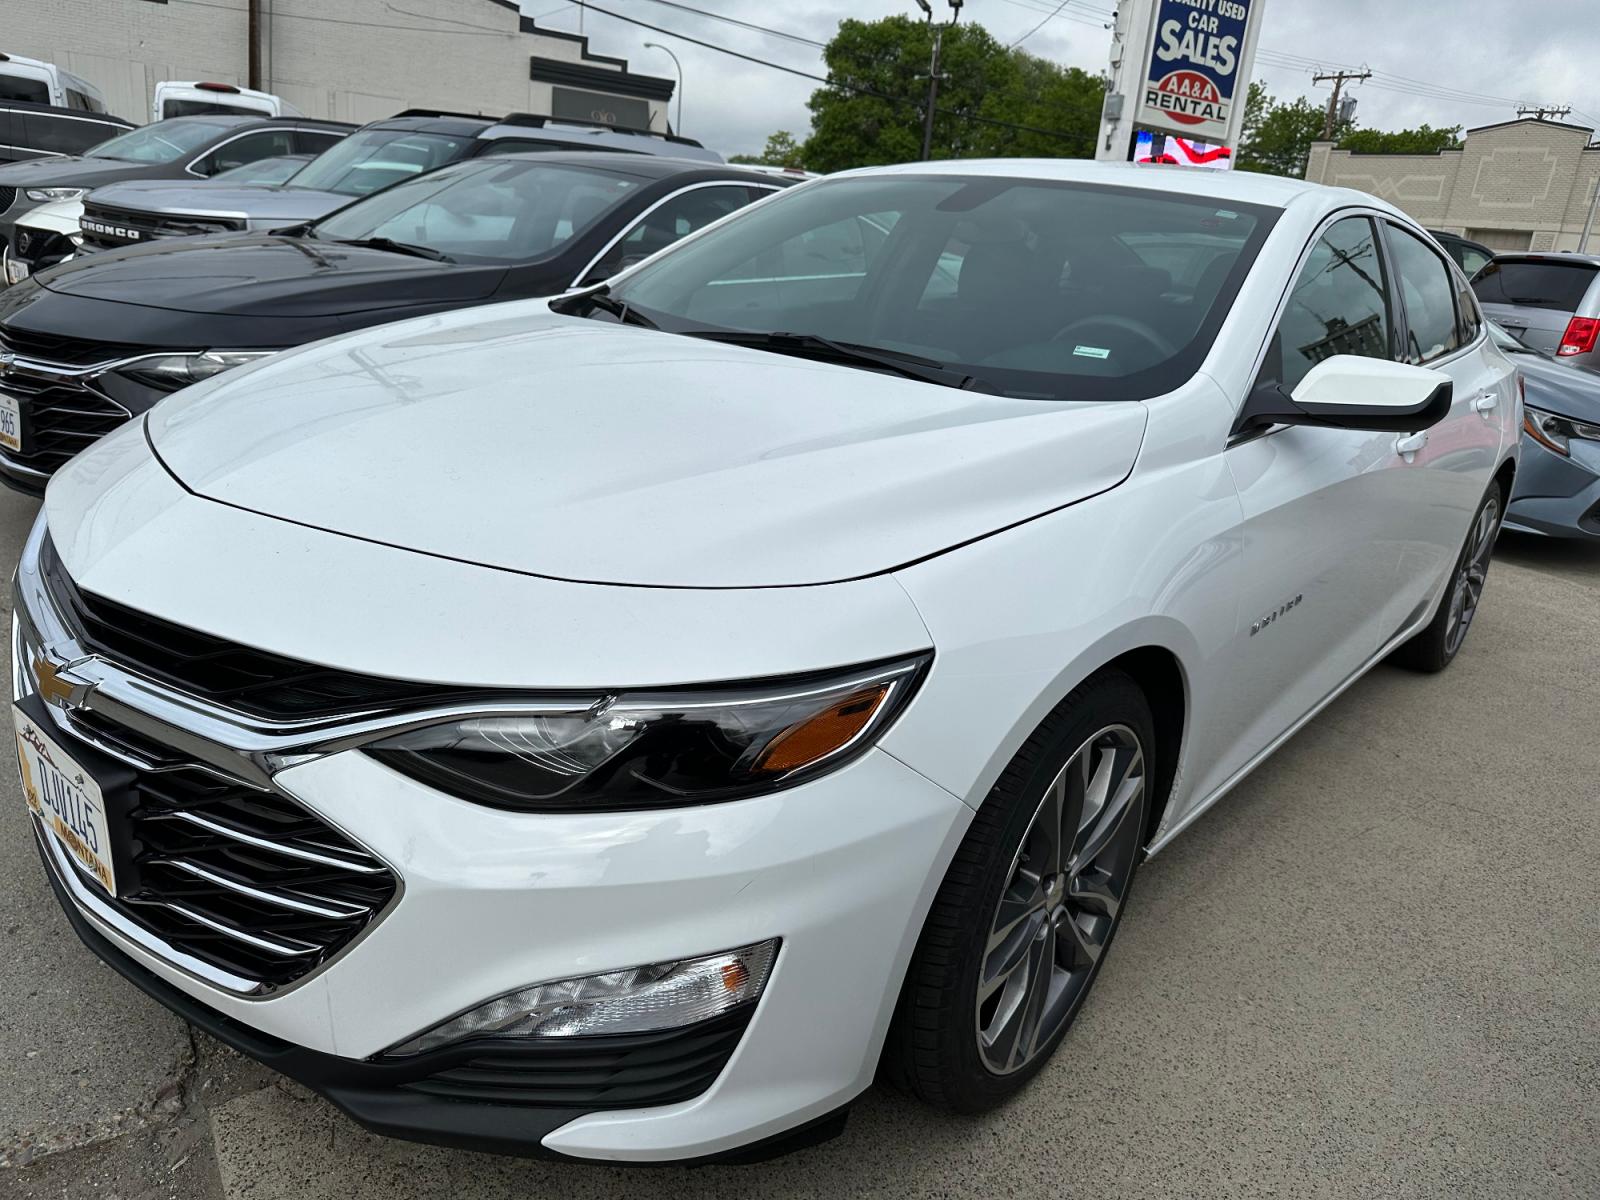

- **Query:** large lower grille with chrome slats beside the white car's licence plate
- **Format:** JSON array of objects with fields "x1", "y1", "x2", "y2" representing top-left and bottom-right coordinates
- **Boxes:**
[{"x1": 54, "y1": 709, "x2": 398, "y2": 987}]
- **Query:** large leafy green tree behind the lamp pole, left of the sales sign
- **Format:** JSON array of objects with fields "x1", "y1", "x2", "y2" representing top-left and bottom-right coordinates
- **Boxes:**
[{"x1": 802, "y1": 16, "x2": 1104, "y2": 171}]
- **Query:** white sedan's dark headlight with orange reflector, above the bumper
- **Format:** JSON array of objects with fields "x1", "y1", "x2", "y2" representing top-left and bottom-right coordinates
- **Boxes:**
[{"x1": 366, "y1": 654, "x2": 928, "y2": 813}]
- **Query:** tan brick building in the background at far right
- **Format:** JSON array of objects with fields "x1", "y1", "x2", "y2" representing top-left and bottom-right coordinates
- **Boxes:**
[{"x1": 1306, "y1": 118, "x2": 1600, "y2": 251}]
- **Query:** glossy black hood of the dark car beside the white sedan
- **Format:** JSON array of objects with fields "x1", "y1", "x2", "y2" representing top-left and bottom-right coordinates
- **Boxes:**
[{"x1": 40, "y1": 234, "x2": 506, "y2": 317}]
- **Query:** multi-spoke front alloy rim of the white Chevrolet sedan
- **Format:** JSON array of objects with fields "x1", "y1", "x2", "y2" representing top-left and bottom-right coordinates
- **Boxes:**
[{"x1": 976, "y1": 725, "x2": 1146, "y2": 1075}]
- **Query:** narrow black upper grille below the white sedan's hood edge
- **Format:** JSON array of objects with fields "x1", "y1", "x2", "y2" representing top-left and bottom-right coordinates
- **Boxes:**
[{"x1": 38, "y1": 539, "x2": 467, "y2": 722}]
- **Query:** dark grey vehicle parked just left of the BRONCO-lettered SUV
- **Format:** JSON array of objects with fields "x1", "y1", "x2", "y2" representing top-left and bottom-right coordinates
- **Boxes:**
[{"x1": 0, "y1": 115, "x2": 355, "y2": 245}]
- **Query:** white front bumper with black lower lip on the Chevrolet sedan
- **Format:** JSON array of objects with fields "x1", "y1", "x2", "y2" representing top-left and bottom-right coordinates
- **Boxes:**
[{"x1": 13, "y1": 476, "x2": 971, "y2": 1162}]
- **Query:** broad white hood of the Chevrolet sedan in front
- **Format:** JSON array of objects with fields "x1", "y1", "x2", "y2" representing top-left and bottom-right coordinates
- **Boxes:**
[{"x1": 149, "y1": 302, "x2": 1146, "y2": 588}]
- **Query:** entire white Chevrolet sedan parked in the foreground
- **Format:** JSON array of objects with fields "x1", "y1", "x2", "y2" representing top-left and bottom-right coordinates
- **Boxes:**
[{"x1": 12, "y1": 162, "x2": 1520, "y2": 1162}]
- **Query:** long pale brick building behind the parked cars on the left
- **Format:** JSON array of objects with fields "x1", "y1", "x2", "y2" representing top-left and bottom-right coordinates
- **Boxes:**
[{"x1": 0, "y1": 0, "x2": 674, "y2": 130}]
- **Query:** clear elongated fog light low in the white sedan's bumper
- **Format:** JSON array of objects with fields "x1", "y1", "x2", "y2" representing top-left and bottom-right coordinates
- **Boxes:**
[{"x1": 389, "y1": 938, "x2": 778, "y2": 1054}]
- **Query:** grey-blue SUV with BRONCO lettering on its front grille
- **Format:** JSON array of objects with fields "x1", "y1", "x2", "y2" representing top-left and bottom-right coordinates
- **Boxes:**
[{"x1": 73, "y1": 109, "x2": 722, "y2": 254}]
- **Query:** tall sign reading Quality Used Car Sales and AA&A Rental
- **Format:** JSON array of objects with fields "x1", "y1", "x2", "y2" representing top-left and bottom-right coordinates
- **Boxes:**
[{"x1": 1094, "y1": 0, "x2": 1266, "y2": 162}]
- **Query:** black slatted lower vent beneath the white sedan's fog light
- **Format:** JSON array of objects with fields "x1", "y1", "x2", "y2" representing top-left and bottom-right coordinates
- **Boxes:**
[{"x1": 390, "y1": 1003, "x2": 755, "y2": 1112}]
